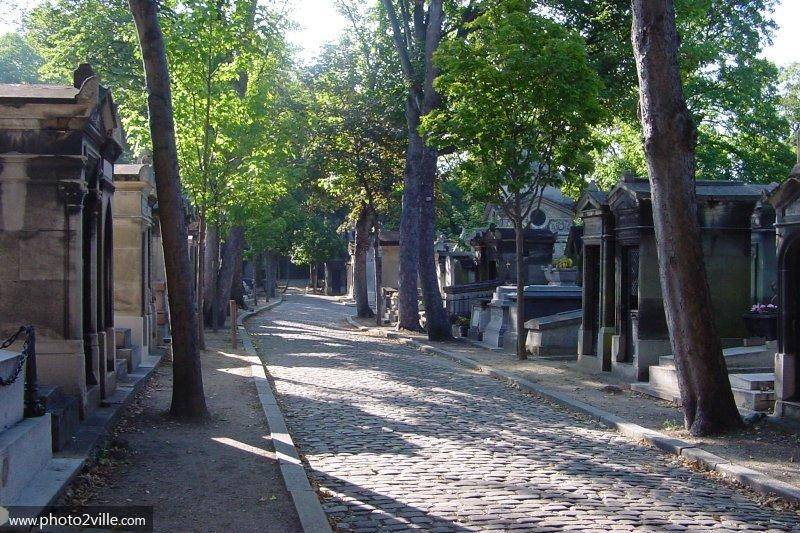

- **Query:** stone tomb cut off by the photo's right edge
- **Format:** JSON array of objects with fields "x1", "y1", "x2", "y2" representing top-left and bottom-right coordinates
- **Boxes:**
[{"x1": 772, "y1": 164, "x2": 800, "y2": 419}]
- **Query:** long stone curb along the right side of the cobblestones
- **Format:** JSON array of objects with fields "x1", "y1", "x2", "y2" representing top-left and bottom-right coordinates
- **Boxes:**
[{"x1": 347, "y1": 316, "x2": 800, "y2": 503}]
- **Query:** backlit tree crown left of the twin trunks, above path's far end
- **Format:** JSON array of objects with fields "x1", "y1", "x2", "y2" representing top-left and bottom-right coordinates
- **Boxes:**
[{"x1": 306, "y1": 3, "x2": 405, "y2": 227}]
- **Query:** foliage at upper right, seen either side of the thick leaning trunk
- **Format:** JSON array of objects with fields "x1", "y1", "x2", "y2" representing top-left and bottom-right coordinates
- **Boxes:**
[{"x1": 547, "y1": 0, "x2": 791, "y2": 182}]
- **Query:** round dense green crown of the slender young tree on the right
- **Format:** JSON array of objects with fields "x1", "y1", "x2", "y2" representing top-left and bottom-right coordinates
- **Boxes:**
[{"x1": 423, "y1": 0, "x2": 601, "y2": 209}]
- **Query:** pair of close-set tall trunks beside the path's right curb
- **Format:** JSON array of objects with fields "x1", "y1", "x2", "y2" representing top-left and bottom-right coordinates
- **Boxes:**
[{"x1": 382, "y1": 0, "x2": 451, "y2": 340}]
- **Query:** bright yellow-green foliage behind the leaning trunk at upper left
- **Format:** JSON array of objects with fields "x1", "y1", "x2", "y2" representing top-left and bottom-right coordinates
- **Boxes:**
[{"x1": 26, "y1": 0, "x2": 308, "y2": 254}]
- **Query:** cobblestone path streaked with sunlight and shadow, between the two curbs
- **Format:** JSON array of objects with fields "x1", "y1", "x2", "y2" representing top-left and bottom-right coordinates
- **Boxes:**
[{"x1": 248, "y1": 295, "x2": 800, "y2": 532}]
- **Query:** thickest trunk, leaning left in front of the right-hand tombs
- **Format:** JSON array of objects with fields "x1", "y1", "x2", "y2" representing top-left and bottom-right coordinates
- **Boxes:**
[{"x1": 633, "y1": 0, "x2": 742, "y2": 435}]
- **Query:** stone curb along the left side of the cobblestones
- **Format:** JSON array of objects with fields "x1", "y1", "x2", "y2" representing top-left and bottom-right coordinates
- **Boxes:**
[{"x1": 238, "y1": 298, "x2": 333, "y2": 533}]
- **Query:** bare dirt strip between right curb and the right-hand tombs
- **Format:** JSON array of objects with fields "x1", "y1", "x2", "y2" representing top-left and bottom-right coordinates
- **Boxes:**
[{"x1": 352, "y1": 314, "x2": 800, "y2": 486}]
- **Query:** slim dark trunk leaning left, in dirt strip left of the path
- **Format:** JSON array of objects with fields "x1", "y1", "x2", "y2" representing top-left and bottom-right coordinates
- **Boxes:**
[{"x1": 129, "y1": 0, "x2": 208, "y2": 419}]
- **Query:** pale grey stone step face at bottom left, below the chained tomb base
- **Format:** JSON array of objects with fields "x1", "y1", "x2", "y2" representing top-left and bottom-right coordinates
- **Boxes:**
[{"x1": 0, "y1": 414, "x2": 53, "y2": 505}]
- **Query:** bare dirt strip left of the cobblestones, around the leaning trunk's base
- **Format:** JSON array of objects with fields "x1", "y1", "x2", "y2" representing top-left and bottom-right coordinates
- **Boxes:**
[{"x1": 62, "y1": 332, "x2": 302, "y2": 533}]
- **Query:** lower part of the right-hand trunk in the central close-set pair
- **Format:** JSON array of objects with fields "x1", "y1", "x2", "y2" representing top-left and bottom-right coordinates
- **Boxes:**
[{"x1": 417, "y1": 139, "x2": 453, "y2": 341}]
